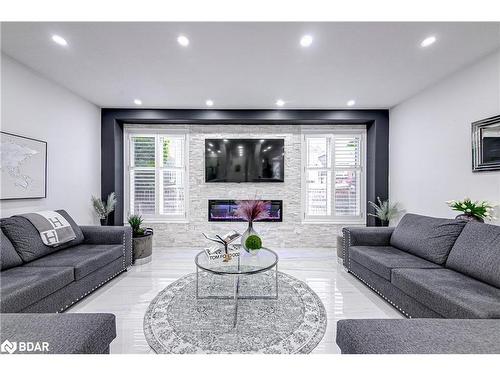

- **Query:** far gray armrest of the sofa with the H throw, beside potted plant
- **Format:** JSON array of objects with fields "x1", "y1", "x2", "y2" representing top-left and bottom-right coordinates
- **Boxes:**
[{"x1": 80, "y1": 225, "x2": 132, "y2": 267}]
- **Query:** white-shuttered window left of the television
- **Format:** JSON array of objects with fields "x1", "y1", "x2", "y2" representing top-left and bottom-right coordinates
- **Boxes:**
[{"x1": 125, "y1": 130, "x2": 188, "y2": 221}]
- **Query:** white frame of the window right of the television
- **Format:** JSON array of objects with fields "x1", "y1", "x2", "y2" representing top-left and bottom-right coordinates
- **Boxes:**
[{"x1": 301, "y1": 125, "x2": 367, "y2": 225}]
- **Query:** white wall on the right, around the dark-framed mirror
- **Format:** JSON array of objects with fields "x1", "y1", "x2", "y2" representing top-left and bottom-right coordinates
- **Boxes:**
[{"x1": 389, "y1": 52, "x2": 500, "y2": 224}]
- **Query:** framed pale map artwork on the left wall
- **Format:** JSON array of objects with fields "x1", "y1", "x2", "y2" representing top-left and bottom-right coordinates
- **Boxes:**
[{"x1": 0, "y1": 132, "x2": 47, "y2": 200}]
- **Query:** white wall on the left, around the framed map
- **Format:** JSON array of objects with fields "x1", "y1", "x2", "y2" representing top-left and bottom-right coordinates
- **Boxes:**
[{"x1": 0, "y1": 54, "x2": 101, "y2": 224}]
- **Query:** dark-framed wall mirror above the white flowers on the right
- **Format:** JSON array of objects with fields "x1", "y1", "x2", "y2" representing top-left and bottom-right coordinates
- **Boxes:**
[{"x1": 472, "y1": 116, "x2": 500, "y2": 172}]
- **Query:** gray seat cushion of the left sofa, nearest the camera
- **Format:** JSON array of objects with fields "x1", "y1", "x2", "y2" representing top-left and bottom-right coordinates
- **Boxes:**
[{"x1": 0, "y1": 266, "x2": 74, "y2": 312}]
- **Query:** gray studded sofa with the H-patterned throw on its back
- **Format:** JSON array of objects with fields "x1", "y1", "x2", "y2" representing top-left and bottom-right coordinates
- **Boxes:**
[{"x1": 0, "y1": 210, "x2": 132, "y2": 313}]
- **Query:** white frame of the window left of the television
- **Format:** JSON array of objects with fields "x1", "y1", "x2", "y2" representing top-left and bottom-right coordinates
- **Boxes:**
[{"x1": 123, "y1": 126, "x2": 189, "y2": 224}]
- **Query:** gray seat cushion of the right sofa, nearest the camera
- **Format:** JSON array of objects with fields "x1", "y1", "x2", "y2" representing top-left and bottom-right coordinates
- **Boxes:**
[{"x1": 391, "y1": 268, "x2": 500, "y2": 319}]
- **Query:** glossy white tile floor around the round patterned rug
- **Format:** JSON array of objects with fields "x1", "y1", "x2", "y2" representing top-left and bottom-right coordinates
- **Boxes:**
[{"x1": 68, "y1": 248, "x2": 402, "y2": 353}]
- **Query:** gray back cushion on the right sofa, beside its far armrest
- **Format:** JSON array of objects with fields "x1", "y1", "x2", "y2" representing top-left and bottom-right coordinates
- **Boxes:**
[{"x1": 391, "y1": 214, "x2": 466, "y2": 265}]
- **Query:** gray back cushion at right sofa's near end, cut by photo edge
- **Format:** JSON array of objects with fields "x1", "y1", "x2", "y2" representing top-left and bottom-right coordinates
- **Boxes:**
[{"x1": 446, "y1": 222, "x2": 500, "y2": 288}]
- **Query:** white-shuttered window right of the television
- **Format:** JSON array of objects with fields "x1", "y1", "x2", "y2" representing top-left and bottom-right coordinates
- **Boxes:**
[{"x1": 302, "y1": 130, "x2": 365, "y2": 223}]
